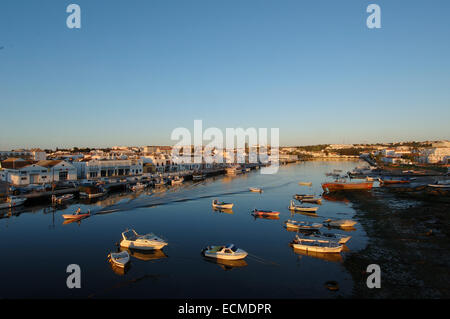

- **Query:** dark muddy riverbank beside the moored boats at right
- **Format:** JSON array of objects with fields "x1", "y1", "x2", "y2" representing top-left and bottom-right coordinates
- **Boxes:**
[{"x1": 344, "y1": 189, "x2": 450, "y2": 298}]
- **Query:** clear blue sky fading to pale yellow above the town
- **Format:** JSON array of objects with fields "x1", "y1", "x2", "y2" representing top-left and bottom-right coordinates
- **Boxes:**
[{"x1": 0, "y1": 0, "x2": 450, "y2": 150}]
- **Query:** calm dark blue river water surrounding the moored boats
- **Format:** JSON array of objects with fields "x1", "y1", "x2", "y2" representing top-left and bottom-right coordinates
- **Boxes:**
[{"x1": 0, "y1": 161, "x2": 366, "y2": 298}]
